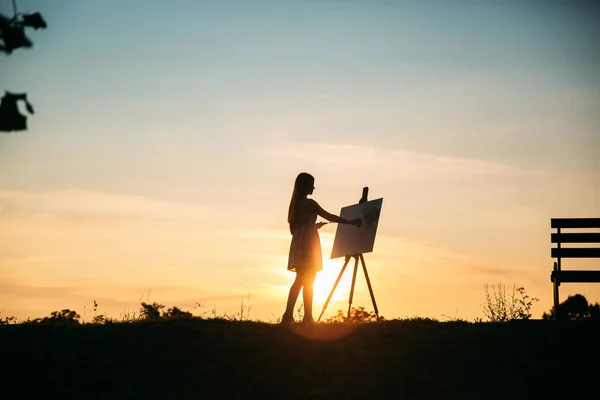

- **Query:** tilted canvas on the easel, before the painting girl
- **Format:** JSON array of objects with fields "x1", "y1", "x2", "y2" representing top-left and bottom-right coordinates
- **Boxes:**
[{"x1": 331, "y1": 198, "x2": 383, "y2": 258}]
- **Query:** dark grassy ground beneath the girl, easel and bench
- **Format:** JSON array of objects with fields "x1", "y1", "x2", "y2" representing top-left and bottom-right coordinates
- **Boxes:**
[{"x1": 0, "y1": 318, "x2": 600, "y2": 399}]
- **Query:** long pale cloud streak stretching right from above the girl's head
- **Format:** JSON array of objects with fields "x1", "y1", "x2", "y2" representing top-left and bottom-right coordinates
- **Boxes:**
[{"x1": 261, "y1": 142, "x2": 600, "y2": 223}]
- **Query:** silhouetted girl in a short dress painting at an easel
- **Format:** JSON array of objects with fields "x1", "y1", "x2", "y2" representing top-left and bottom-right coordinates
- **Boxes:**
[{"x1": 282, "y1": 172, "x2": 362, "y2": 323}]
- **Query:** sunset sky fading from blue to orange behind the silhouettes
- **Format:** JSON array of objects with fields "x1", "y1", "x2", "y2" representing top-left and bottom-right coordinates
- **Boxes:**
[{"x1": 0, "y1": 0, "x2": 600, "y2": 321}]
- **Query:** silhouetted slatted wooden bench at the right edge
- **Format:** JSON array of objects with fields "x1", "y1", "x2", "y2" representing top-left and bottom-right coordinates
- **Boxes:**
[{"x1": 550, "y1": 218, "x2": 600, "y2": 319}]
